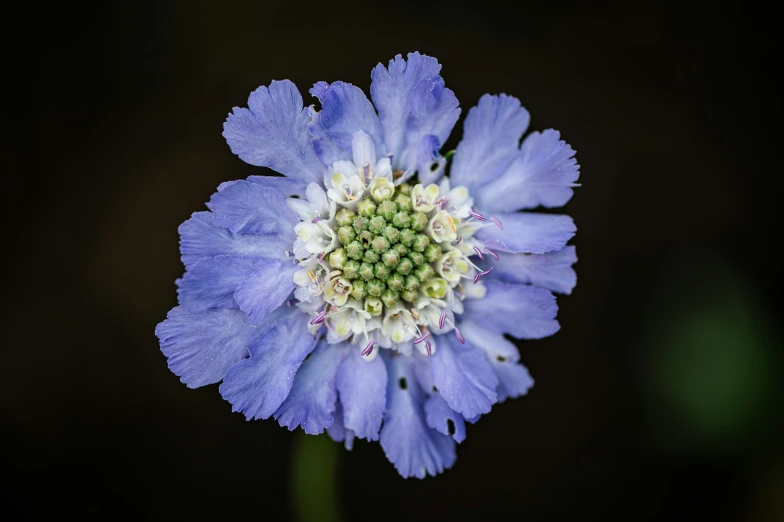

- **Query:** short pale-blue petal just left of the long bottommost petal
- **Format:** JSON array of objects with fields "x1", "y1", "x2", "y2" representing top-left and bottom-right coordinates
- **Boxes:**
[{"x1": 337, "y1": 349, "x2": 387, "y2": 440}]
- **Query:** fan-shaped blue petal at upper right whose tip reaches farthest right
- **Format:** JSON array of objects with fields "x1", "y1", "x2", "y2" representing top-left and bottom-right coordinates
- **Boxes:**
[{"x1": 472, "y1": 129, "x2": 580, "y2": 212}]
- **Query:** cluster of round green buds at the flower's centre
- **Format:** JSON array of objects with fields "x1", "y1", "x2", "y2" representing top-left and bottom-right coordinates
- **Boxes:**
[{"x1": 327, "y1": 184, "x2": 447, "y2": 316}]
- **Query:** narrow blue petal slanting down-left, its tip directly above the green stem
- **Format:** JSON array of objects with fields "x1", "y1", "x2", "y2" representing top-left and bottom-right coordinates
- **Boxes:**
[{"x1": 275, "y1": 343, "x2": 346, "y2": 435}]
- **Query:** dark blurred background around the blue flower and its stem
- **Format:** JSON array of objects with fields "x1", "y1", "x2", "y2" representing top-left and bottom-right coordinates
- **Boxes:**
[{"x1": 0, "y1": 1, "x2": 784, "y2": 521}]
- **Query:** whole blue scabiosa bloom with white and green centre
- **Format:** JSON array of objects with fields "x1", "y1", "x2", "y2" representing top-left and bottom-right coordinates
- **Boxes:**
[{"x1": 156, "y1": 53, "x2": 579, "y2": 478}]
